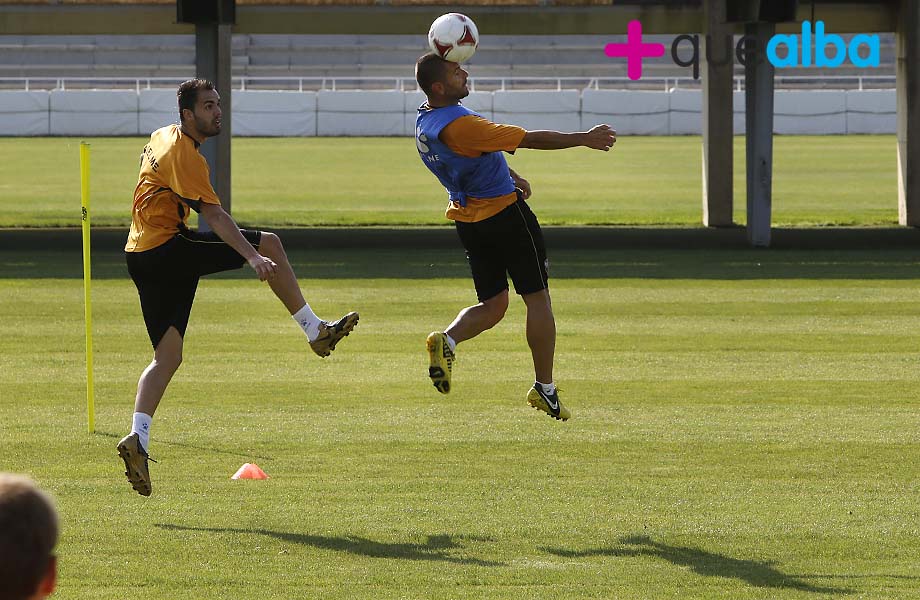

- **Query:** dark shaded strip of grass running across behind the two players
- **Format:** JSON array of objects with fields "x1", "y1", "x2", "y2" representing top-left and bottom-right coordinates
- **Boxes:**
[{"x1": 0, "y1": 248, "x2": 920, "y2": 286}]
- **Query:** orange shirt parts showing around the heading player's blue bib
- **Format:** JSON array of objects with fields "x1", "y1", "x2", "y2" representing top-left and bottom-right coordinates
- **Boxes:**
[{"x1": 438, "y1": 115, "x2": 527, "y2": 223}]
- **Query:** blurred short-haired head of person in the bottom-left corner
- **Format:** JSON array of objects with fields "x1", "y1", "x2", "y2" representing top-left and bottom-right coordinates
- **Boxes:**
[{"x1": 0, "y1": 473, "x2": 58, "y2": 600}]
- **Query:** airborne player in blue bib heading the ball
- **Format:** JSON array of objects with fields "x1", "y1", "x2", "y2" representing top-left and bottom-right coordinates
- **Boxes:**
[{"x1": 415, "y1": 53, "x2": 616, "y2": 421}]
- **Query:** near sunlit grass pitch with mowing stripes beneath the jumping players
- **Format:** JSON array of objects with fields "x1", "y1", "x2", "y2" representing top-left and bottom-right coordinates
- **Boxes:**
[{"x1": 0, "y1": 250, "x2": 920, "y2": 600}]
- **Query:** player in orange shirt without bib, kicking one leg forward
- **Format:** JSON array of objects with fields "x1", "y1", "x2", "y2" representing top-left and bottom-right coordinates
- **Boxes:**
[{"x1": 117, "y1": 79, "x2": 358, "y2": 496}]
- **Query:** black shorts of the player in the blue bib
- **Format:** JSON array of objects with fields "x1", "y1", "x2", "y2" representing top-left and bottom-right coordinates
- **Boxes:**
[{"x1": 456, "y1": 195, "x2": 549, "y2": 302}]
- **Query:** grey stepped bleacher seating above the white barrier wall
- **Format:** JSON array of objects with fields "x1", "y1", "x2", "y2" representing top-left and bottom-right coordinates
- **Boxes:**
[{"x1": 0, "y1": 34, "x2": 894, "y2": 84}]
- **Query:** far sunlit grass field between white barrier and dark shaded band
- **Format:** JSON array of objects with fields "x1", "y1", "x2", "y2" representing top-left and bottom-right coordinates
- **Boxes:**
[{"x1": 0, "y1": 136, "x2": 897, "y2": 227}]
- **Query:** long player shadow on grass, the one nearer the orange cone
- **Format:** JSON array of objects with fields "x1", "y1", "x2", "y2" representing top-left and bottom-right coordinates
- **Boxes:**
[{"x1": 155, "y1": 523, "x2": 505, "y2": 567}]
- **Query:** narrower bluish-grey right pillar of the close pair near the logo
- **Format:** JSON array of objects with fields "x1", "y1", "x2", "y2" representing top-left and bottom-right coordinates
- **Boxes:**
[{"x1": 744, "y1": 23, "x2": 776, "y2": 247}]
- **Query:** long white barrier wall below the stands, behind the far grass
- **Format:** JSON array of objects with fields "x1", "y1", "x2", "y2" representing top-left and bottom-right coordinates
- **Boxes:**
[{"x1": 0, "y1": 89, "x2": 897, "y2": 136}]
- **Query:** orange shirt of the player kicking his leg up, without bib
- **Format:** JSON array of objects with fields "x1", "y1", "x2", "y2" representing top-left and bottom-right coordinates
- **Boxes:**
[{"x1": 125, "y1": 125, "x2": 220, "y2": 252}]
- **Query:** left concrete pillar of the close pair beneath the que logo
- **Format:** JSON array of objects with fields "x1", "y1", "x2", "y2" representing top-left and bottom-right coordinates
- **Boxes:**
[{"x1": 700, "y1": 0, "x2": 735, "y2": 227}]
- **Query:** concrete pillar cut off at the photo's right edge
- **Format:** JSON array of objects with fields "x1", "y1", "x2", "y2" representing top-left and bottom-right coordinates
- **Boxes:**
[{"x1": 895, "y1": 0, "x2": 920, "y2": 227}]
